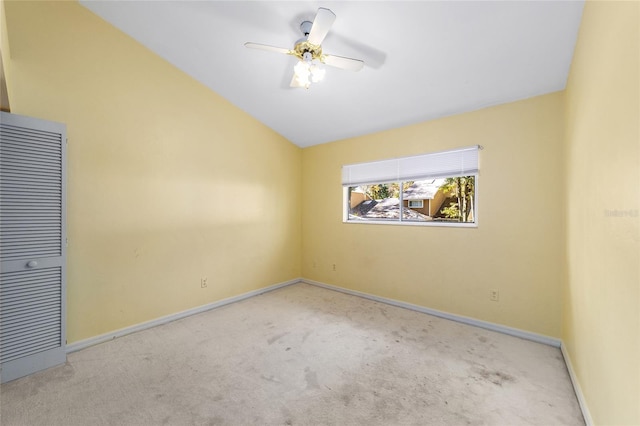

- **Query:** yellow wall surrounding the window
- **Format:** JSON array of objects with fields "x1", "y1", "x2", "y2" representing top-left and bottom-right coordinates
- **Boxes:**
[{"x1": 302, "y1": 93, "x2": 564, "y2": 337}]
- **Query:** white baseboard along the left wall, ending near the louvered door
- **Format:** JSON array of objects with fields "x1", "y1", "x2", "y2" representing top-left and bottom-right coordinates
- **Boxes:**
[{"x1": 66, "y1": 278, "x2": 301, "y2": 354}]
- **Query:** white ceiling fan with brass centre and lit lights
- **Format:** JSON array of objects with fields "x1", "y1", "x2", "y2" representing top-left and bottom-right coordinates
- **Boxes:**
[{"x1": 244, "y1": 7, "x2": 364, "y2": 89}]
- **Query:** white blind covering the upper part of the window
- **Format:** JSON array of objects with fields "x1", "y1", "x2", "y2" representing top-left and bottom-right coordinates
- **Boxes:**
[{"x1": 342, "y1": 145, "x2": 480, "y2": 186}]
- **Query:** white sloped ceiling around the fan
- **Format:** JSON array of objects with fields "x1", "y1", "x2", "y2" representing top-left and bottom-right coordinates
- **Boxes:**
[{"x1": 81, "y1": 0, "x2": 583, "y2": 147}]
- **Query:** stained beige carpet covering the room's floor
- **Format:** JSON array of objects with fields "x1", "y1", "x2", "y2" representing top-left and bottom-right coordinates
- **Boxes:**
[{"x1": 0, "y1": 284, "x2": 584, "y2": 426}]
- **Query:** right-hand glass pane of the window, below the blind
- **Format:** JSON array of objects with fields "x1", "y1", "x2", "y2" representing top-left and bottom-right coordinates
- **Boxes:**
[{"x1": 402, "y1": 176, "x2": 475, "y2": 223}]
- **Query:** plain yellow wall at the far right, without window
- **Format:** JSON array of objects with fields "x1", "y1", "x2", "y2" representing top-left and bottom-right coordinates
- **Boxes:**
[{"x1": 563, "y1": 2, "x2": 640, "y2": 425}]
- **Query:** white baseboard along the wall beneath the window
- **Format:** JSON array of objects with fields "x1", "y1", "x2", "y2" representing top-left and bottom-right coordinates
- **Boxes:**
[{"x1": 301, "y1": 278, "x2": 561, "y2": 348}]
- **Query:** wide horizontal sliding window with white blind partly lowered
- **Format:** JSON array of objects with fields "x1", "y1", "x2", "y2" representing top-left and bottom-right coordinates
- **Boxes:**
[{"x1": 342, "y1": 146, "x2": 479, "y2": 226}]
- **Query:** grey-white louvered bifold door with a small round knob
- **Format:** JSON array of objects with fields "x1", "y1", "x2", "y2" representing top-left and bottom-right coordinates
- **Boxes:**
[{"x1": 0, "y1": 112, "x2": 66, "y2": 383}]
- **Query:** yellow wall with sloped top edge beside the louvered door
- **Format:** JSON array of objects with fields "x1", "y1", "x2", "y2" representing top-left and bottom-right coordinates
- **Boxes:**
[{"x1": 5, "y1": 1, "x2": 301, "y2": 343}]
